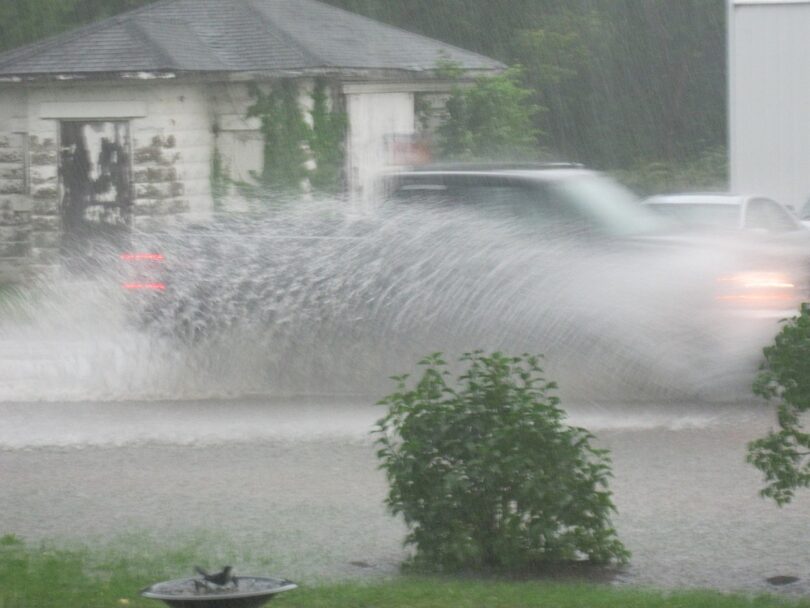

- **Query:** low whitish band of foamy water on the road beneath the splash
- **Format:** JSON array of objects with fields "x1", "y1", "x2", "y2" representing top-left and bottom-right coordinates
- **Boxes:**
[{"x1": 0, "y1": 397, "x2": 772, "y2": 451}]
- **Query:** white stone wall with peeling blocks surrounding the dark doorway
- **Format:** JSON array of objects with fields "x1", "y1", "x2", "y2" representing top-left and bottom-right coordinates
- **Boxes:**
[{"x1": 0, "y1": 81, "x2": 213, "y2": 280}]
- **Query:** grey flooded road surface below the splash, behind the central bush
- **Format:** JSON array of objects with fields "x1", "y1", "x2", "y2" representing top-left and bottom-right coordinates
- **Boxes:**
[{"x1": 0, "y1": 398, "x2": 810, "y2": 593}]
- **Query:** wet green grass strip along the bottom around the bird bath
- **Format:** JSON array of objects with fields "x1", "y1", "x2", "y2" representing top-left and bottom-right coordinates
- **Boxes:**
[{"x1": 0, "y1": 535, "x2": 810, "y2": 608}]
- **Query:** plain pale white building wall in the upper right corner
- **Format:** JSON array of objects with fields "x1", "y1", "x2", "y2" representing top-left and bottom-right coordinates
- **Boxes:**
[{"x1": 729, "y1": 2, "x2": 810, "y2": 208}]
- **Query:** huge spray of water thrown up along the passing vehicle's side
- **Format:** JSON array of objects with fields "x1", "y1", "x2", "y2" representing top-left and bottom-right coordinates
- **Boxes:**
[{"x1": 0, "y1": 203, "x2": 774, "y2": 402}]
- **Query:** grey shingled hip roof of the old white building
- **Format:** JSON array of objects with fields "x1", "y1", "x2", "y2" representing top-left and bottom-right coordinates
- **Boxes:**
[{"x1": 0, "y1": 0, "x2": 504, "y2": 77}]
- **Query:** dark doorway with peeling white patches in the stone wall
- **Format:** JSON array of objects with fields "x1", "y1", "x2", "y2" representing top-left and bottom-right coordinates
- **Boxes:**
[{"x1": 59, "y1": 121, "x2": 132, "y2": 269}]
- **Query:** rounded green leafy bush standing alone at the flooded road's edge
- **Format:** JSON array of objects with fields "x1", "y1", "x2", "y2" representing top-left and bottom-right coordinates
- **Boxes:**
[{"x1": 375, "y1": 351, "x2": 629, "y2": 570}]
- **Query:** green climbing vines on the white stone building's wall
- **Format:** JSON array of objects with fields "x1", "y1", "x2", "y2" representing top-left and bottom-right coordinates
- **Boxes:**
[{"x1": 247, "y1": 79, "x2": 346, "y2": 193}]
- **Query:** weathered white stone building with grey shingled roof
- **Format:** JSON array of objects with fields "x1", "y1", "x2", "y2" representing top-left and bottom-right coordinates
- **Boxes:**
[{"x1": 0, "y1": 0, "x2": 504, "y2": 280}]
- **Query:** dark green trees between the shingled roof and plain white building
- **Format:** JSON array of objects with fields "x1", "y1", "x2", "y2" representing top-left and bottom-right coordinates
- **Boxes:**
[{"x1": 329, "y1": 0, "x2": 726, "y2": 173}]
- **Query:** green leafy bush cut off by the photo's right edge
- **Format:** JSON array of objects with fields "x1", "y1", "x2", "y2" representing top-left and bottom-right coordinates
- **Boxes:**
[{"x1": 748, "y1": 304, "x2": 810, "y2": 506}]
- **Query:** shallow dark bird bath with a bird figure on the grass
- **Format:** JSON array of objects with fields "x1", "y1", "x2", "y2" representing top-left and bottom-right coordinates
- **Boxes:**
[{"x1": 141, "y1": 576, "x2": 298, "y2": 608}]
